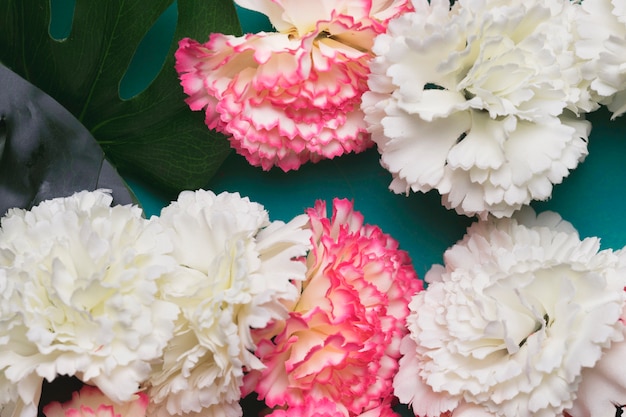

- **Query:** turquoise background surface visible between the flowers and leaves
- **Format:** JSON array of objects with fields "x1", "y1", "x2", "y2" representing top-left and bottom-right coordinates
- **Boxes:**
[{"x1": 120, "y1": 1, "x2": 626, "y2": 277}]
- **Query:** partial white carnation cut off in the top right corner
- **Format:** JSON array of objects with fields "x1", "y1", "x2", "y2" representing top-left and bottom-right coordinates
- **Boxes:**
[{"x1": 576, "y1": 0, "x2": 626, "y2": 118}]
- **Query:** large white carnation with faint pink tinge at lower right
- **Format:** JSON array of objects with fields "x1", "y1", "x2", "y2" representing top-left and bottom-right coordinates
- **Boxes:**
[{"x1": 394, "y1": 209, "x2": 626, "y2": 417}]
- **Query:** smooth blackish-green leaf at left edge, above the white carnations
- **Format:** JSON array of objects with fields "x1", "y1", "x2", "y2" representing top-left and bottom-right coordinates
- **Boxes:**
[{"x1": 0, "y1": 65, "x2": 132, "y2": 215}]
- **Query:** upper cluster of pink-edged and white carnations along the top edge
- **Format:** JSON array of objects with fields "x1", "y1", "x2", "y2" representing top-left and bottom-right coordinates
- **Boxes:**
[{"x1": 176, "y1": 0, "x2": 626, "y2": 219}]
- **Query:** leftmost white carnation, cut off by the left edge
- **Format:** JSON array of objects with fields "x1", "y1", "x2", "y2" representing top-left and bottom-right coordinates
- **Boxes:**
[{"x1": 0, "y1": 191, "x2": 178, "y2": 417}]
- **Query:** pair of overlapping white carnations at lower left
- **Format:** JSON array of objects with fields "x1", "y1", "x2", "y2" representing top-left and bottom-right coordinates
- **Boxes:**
[{"x1": 0, "y1": 190, "x2": 311, "y2": 417}]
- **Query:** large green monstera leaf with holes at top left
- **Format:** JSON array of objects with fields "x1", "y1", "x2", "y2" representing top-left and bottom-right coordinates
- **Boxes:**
[{"x1": 0, "y1": 0, "x2": 241, "y2": 194}]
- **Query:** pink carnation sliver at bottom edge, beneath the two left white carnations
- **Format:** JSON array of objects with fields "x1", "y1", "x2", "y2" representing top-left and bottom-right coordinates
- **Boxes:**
[{"x1": 43, "y1": 385, "x2": 149, "y2": 417}]
